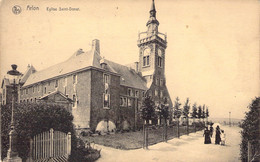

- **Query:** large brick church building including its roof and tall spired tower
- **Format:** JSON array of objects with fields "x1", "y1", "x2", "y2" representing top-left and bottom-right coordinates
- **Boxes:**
[{"x1": 8, "y1": 1, "x2": 172, "y2": 131}]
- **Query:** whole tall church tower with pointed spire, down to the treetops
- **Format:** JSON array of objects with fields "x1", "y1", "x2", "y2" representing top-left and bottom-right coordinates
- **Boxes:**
[{"x1": 137, "y1": 0, "x2": 170, "y2": 103}]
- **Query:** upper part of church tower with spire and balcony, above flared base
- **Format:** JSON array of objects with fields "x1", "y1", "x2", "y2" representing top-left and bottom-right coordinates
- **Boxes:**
[{"x1": 137, "y1": 0, "x2": 167, "y2": 85}]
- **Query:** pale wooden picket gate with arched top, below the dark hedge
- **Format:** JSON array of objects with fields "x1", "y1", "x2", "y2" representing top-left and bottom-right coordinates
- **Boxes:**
[{"x1": 27, "y1": 128, "x2": 71, "y2": 162}]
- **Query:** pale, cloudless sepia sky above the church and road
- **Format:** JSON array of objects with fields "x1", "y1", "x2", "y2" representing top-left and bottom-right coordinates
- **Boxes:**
[{"x1": 0, "y1": 0, "x2": 260, "y2": 118}]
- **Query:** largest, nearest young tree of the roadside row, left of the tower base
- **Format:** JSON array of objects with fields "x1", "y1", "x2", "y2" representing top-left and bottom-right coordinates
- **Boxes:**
[{"x1": 141, "y1": 95, "x2": 155, "y2": 149}]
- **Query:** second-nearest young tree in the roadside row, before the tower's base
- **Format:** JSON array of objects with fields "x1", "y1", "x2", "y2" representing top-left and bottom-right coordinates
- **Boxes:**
[{"x1": 158, "y1": 98, "x2": 170, "y2": 142}]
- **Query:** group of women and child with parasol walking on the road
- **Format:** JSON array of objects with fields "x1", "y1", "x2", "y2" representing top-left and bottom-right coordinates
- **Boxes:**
[{"x1": 203, "y1": 124, "x2": 226, "y2": 146}]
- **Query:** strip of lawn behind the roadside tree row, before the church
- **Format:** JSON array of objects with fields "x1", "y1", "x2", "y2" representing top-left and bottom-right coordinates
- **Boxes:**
[{"x1": 82, "y1": 126, "x2": 203, "y2": 150}]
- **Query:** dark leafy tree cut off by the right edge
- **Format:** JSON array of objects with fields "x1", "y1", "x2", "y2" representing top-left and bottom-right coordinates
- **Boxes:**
[{"x1": 240, "y1": 97, "x2": 260, "y2": 162}]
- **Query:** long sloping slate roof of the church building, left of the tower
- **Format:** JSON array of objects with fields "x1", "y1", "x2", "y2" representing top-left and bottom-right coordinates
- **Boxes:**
[{"x1": 24, "y1": 49, "x2": 147, "y2": 90}]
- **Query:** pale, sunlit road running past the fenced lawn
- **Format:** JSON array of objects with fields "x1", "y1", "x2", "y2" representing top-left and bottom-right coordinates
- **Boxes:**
[{"x1": 96, "y1": 126, "x2": 241, "y2": 162}]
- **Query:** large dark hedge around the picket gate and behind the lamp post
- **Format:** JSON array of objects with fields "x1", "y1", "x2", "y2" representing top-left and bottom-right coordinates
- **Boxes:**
[{"x1": 1, "y1": 103, "x2": 76, "y2": 161}]
